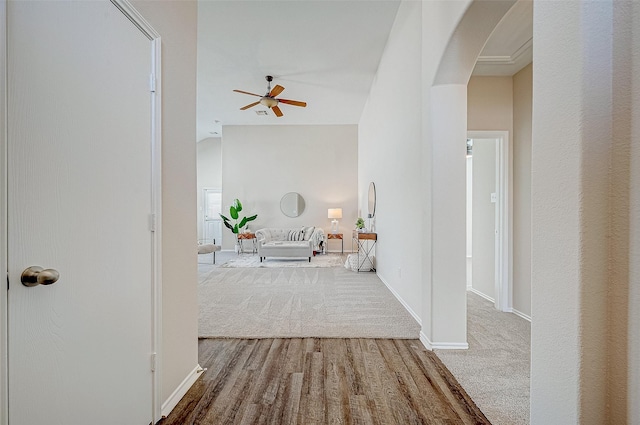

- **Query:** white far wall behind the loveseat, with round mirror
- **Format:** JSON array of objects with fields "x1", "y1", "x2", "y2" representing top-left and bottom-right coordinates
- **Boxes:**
[{"x1": 222, "y1": 125, "x2": 358, "y2": 251}]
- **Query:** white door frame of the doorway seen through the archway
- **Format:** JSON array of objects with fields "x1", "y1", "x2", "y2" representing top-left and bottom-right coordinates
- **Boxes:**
[{"x1": 467, "y1": 131, "x2": 513, "y2": 312}]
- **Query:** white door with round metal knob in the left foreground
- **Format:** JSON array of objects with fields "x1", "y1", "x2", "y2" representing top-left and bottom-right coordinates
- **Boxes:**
[{"x1": 7, "y1": 0, "x2": 153, "y2": 425}]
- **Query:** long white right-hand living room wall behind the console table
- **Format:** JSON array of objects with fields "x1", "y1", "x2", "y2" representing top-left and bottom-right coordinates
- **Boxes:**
[{"x1": 358, "y1": 2, "x2": 426, "y2": 320}]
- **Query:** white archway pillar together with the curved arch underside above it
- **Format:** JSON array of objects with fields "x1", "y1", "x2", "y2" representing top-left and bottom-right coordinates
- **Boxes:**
[{"x1": 423, "y1": 0, "x2": 516, "y2": 348}]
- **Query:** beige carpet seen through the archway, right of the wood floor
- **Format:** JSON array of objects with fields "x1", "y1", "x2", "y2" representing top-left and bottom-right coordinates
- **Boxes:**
[{"x1": 434, "y1": 292, "x2": 531, "y2": 425}]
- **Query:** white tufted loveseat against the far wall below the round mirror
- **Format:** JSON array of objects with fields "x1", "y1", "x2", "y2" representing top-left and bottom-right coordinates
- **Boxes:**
[{"x1": 256, "y1": 227, "x2": 324, "y2": 262}]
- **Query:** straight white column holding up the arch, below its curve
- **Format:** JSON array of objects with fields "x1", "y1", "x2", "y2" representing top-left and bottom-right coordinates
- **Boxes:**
[{"x1": 423, "y1": 84, "x2": 468, "y2": 348}]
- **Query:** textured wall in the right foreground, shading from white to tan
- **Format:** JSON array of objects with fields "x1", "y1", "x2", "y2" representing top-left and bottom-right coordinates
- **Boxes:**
[{"x1": 531, "y1": 1, "x2": 640, "y2": 424}]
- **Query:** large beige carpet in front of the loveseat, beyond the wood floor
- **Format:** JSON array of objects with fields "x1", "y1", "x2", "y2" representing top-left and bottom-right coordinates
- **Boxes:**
[{"x1": 198, "y1": 264, "x2": 420, "y2": 339}]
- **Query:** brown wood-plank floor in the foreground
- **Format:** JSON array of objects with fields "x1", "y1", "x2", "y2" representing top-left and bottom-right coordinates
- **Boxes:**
[{"x1": 160, "y1": 338, "x2": 489, "y2": 425}]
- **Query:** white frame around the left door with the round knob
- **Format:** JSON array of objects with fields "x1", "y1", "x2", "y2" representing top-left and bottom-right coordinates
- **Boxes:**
[{"x1": 0, "y1": 0, "x2": 162, "y2": 425}]
